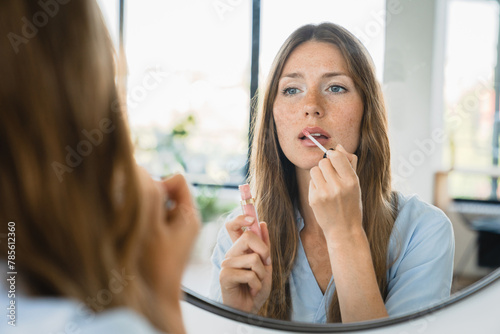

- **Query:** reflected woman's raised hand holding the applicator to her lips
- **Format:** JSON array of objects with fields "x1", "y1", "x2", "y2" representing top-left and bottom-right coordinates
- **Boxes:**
[{"x1": 309, "y1": 144, "x2": 363, "y2": 239}]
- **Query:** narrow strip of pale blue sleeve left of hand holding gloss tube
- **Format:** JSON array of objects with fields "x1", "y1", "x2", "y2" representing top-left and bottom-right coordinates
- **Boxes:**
[{"x1": 208, "y1": 215, "x2": 233, "y2": 303}]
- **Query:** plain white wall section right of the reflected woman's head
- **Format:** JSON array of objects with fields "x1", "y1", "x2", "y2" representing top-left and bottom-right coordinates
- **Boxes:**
[{"x1": 383, "y1": 0, "x2": 446, "y2": 202}]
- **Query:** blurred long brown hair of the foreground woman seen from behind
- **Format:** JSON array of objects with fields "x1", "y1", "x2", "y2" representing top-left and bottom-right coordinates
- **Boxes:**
[{"x1": 0, "y1": 0, "x2": 168, "y2": 330}]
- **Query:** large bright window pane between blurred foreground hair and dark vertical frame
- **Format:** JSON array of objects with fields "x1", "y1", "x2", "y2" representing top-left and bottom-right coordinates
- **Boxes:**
[{"x1": 125, "y1": 0, "x2": 251, "y2": 185}]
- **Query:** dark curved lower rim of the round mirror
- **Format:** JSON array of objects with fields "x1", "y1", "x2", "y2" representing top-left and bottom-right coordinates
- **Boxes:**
[{"x1": 182, "y1": 268, "x2": 500, "y2": 333}]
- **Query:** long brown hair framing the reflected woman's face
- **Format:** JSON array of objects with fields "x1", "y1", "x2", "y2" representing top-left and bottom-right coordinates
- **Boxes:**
[{"x1": 250, "y1": 23, "x2": 397, "y2": 322}]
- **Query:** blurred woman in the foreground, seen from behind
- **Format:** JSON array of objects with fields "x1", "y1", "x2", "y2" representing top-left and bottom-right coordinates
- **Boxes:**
[{"x1": 0, "y1": 0, "x2": 199, "y2": 333}]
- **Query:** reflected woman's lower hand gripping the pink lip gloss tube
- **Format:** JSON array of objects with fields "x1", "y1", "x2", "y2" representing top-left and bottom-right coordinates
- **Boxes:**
[{"x1": 219, "y1": 215, "x2": 272, "y2": 314}]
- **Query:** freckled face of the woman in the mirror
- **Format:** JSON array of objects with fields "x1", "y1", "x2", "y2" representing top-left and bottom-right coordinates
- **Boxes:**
[{"x1": 273, "y1": 41, "x2": 363, "y2": 170}]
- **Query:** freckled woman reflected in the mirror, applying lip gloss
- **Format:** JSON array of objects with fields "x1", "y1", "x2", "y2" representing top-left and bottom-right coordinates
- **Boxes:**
[{"x1": 211, "y1": 23, "x2": 454, "y2": 322}]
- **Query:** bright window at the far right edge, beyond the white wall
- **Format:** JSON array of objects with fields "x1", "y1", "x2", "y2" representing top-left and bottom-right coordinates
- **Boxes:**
[{"x1": 443, "y1": 0, "x2": 499, "y2": 199}]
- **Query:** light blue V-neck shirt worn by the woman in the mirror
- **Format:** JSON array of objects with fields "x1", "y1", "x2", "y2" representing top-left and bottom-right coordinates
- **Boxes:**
[{"x1": 209, "y1": 194, "x2": 455, "y2": 323}]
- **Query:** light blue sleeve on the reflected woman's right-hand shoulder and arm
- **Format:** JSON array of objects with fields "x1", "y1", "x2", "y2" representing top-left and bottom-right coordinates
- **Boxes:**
[{"x1": 385, "y1": 197, "x2": 455, "y2": 316}]
